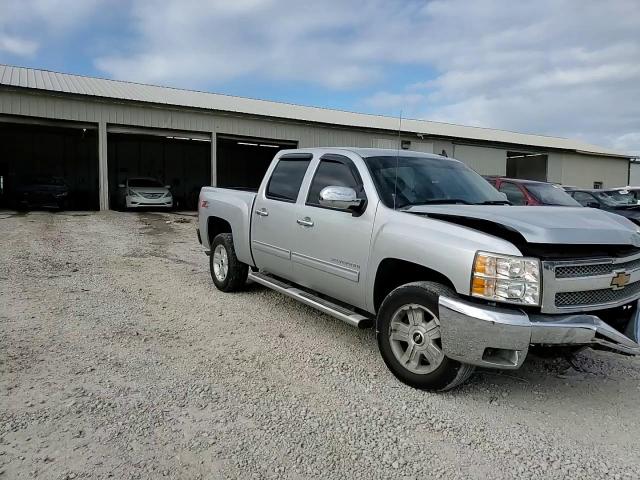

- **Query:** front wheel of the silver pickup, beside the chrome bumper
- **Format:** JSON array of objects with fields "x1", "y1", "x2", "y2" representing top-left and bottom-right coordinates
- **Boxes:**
[{"x1": 376, "y1": 282, "x2": 475, "y2": 392}]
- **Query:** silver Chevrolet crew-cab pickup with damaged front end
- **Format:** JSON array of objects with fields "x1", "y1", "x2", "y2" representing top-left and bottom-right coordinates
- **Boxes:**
[{"x1": 198, "y1": 148, "x2": 640, "y2": 391}]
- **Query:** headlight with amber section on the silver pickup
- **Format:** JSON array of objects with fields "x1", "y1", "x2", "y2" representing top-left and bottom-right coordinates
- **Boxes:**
[{"x1": 471, "y1": 252, "x2": 540, "y2": 305}]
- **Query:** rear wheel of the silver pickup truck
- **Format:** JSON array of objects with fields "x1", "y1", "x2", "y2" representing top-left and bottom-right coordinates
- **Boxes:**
[{"x1": 209, "y1": 233, "x2": 249, "y2": 292}]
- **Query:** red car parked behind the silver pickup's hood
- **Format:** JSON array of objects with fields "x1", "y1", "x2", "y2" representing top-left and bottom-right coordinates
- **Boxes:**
[{"x1": 485, "y1": 177, "x2": 580, "y2": 207}]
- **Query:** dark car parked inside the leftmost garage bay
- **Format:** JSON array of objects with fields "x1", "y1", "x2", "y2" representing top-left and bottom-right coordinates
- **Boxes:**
[{"x1": 12, "y1": 175, "x2": 69, "y2": 210}]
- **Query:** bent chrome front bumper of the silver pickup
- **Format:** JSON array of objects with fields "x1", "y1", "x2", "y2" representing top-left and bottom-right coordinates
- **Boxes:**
[{"x1": 439, "y1": 297, "x2": 640, "y2": 369}]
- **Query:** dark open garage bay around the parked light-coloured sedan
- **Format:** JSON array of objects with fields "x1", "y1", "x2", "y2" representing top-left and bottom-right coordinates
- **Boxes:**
[{"x1": 107, "y1": 130, "x2": 211, "y2": 210}]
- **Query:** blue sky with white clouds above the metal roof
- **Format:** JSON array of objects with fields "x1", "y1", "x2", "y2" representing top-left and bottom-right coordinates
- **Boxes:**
[{"x1": 0, "y1": 0, "x2": 640, "y2": 155}]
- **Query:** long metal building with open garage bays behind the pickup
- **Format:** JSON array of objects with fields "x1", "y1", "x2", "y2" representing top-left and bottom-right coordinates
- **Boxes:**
[{"x1": 0, "y1": 65, "x2": 630, "y2": 209}]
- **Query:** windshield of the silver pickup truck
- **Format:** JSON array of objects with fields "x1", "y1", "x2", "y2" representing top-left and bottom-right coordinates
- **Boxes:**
[{"x1": 365, "y1": 156, "x2": 508, "y2": 208}]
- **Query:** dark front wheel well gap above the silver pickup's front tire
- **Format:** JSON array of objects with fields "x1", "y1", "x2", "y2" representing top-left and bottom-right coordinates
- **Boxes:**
[{"x1": 373, "y1": 258, "x2": 455, "y2": 312}]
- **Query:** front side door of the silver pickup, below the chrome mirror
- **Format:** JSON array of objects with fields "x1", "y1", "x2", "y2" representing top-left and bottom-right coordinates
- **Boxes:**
[{"x1": 291, "y1": 154, "x2": 375, "y2": 307}]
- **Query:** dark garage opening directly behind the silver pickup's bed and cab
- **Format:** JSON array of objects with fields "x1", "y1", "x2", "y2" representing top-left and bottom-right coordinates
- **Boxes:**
[{"x1": 216, "y1": 135, "x2": 298, "y2": 190}]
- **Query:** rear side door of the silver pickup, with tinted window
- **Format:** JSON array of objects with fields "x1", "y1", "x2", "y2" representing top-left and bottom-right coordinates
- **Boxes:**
[{"x1": 251, "y1": 153, "x2": 312, "y2": 280}]
